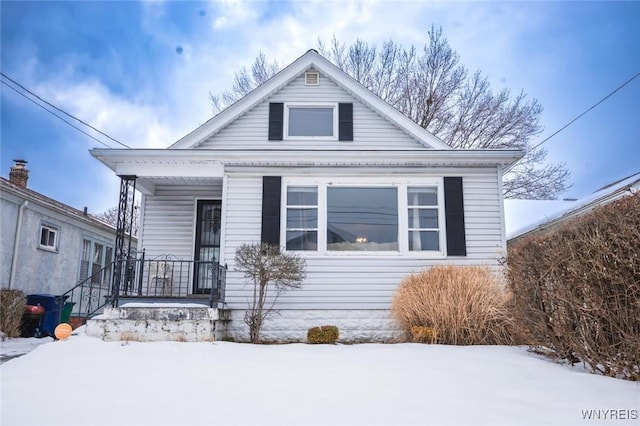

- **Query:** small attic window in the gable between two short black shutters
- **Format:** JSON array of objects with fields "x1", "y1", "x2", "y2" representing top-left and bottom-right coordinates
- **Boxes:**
[{"x1": 285, "y1": 104, "x2": 338, "y2": 139}]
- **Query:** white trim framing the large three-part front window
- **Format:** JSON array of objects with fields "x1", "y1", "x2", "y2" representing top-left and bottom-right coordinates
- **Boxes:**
[{"x1": 280, "y1": 178, "x2": 446, "y2": 259}]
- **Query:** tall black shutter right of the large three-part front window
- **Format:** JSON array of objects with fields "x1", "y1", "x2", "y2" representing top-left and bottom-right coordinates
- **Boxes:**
[{"x1": 444, "y1": 177, "x2": 467, "y2": 256}]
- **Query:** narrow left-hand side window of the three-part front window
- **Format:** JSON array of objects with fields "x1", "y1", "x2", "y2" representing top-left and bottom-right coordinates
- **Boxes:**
[{"x1": 286, "y1": 186, "x2": 318, "y2": 250}]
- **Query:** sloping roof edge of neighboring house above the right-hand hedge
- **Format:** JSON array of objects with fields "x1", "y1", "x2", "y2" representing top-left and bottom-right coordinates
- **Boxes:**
[{"x1": 505, "y1": 172, "x2": 640, "y2": 241}]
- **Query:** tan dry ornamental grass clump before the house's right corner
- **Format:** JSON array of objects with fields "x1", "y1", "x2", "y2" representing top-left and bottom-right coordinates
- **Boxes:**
[{"x1": 391, "y1": 266, "x2": 517, "y2": 345}]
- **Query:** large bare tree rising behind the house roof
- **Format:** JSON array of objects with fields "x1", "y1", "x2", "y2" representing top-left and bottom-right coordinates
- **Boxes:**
[{"x1": 210, "y1": 27, "x2": 570, "y2": 199}]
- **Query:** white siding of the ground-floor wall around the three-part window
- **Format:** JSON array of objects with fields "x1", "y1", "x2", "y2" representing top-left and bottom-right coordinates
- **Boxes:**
[{"x1": 223, "y1": 169, "x2": 503, "y2": 309}]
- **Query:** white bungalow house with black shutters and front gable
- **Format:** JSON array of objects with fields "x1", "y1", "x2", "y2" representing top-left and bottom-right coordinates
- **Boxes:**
[{"x1": 91, "y1": 50, "x2": 523, "y2": 341}]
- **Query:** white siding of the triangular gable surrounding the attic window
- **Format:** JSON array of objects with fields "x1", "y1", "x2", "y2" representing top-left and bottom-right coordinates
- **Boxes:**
[{"x1": 198, "y1": 70, "x2": 424, "y2": 149}]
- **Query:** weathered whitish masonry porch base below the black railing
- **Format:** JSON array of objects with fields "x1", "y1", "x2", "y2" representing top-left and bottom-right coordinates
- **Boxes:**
[{"x1": 86, "y1": 303, "x2": 230, "y2": 342}]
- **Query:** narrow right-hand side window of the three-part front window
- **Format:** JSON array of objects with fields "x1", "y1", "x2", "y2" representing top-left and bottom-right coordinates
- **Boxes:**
[{"x1": 407, "y1": 186, "x2": 440, "y2": 251}]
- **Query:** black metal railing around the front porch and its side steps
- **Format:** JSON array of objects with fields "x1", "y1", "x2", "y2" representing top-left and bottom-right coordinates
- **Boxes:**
[{"x1": 61, "y1": 252, "x2": 227, "y2": 320}]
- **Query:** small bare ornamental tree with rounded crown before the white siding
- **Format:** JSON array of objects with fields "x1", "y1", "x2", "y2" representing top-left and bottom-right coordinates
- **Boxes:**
[{"x1": 235, "y1": 243, "x2": 306, "y2": 343}]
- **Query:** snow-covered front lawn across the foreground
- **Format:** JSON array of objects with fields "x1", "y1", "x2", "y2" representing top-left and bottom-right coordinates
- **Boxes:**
[{"x1": 0, "y1": 332, "x2": 640, "y2": 426}]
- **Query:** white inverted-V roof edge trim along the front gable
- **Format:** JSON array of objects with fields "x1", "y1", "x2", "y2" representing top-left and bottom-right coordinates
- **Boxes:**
[{"x1": 169, "y1": 49, "x2": 453, "y2": 150}]
